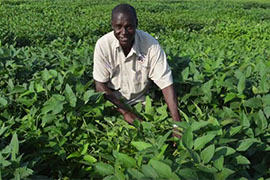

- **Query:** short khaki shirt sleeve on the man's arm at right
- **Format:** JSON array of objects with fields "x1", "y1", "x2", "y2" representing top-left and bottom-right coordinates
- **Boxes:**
[{"x1": 149, "y1": 44, "x2": 173, "y2": 89}]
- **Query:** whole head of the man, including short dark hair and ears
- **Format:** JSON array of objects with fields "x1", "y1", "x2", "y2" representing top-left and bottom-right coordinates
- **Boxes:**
[{"x1": 111, "y1": 4, "x2": 138, "y2": 48}]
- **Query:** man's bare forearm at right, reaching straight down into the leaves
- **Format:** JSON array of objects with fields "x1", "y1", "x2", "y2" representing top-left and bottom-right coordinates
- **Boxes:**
[{"x1": 162, "y1": 85, "x2": 181, "y2": 138}]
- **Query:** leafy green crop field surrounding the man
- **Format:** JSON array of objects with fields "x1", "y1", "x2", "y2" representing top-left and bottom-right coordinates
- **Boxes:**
[{"x1": 0, "y1": 0, "x2": 270, "y2": 180}]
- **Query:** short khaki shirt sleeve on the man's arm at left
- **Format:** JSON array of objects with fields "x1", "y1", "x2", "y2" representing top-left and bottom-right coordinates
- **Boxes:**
[{"x1": 93, "y1": 41, "x2": 110, "y2": 82}]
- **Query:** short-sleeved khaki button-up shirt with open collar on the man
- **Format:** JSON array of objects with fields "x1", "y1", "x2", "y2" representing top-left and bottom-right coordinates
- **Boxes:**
[{"x1": 93, "y1": 30, "x2": 173, "y2": 105}]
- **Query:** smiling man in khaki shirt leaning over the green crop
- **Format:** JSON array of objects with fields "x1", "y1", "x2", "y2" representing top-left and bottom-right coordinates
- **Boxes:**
[{"x1": 93, "y1": 4, "x2": 180, "y2": 134}]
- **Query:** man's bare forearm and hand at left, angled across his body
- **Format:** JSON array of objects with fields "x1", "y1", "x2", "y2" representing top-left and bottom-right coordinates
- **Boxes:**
[{"x1": 95, "y1": 81, "x2": 140, "y2": 124}]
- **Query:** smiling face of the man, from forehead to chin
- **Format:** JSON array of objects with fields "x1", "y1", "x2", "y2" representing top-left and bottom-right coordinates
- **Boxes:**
[{"x1": 112, "y1": 13, "x2": 137, "y2": 48}]
